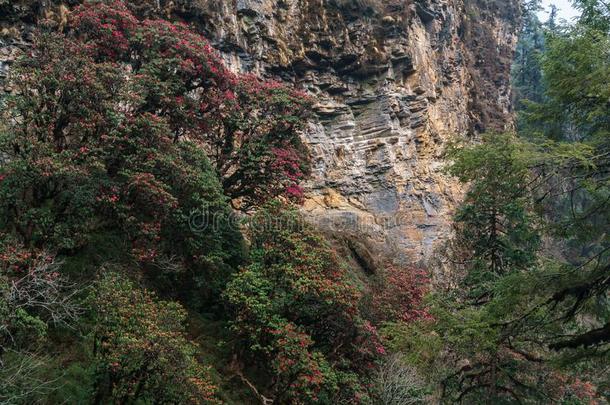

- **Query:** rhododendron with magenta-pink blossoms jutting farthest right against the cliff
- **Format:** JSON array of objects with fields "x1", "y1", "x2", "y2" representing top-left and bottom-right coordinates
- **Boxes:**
[{"x1": 210, "y1": 75, "x2": 310, "y2": 205}]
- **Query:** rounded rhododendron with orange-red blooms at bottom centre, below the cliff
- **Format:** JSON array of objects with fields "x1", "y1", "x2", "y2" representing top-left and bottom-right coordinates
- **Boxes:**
[{"x1": 225, "y1": 203, "x2": 385, "y2": 403}]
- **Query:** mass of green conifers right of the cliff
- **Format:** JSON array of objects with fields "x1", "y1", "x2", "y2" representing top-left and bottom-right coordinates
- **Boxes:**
[{"x1": 420, "y1": 4, "x2": 610, "y2": 392}]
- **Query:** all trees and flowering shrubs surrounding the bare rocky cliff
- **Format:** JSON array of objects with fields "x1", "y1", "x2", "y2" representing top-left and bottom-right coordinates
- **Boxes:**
[{"x1": 0, "y1": 0, "x2": 610, "y2": 405}]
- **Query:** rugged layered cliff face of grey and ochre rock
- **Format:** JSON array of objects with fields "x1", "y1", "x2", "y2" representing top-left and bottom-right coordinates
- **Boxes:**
[{"x1": 0, "y1": 0, "x2": 519, "y2": 262}]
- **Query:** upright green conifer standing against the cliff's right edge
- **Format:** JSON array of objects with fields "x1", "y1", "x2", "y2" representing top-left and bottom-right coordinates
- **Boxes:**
[{"x1": 449, "y1": 135, "x2": 540, "y2": 301}]
